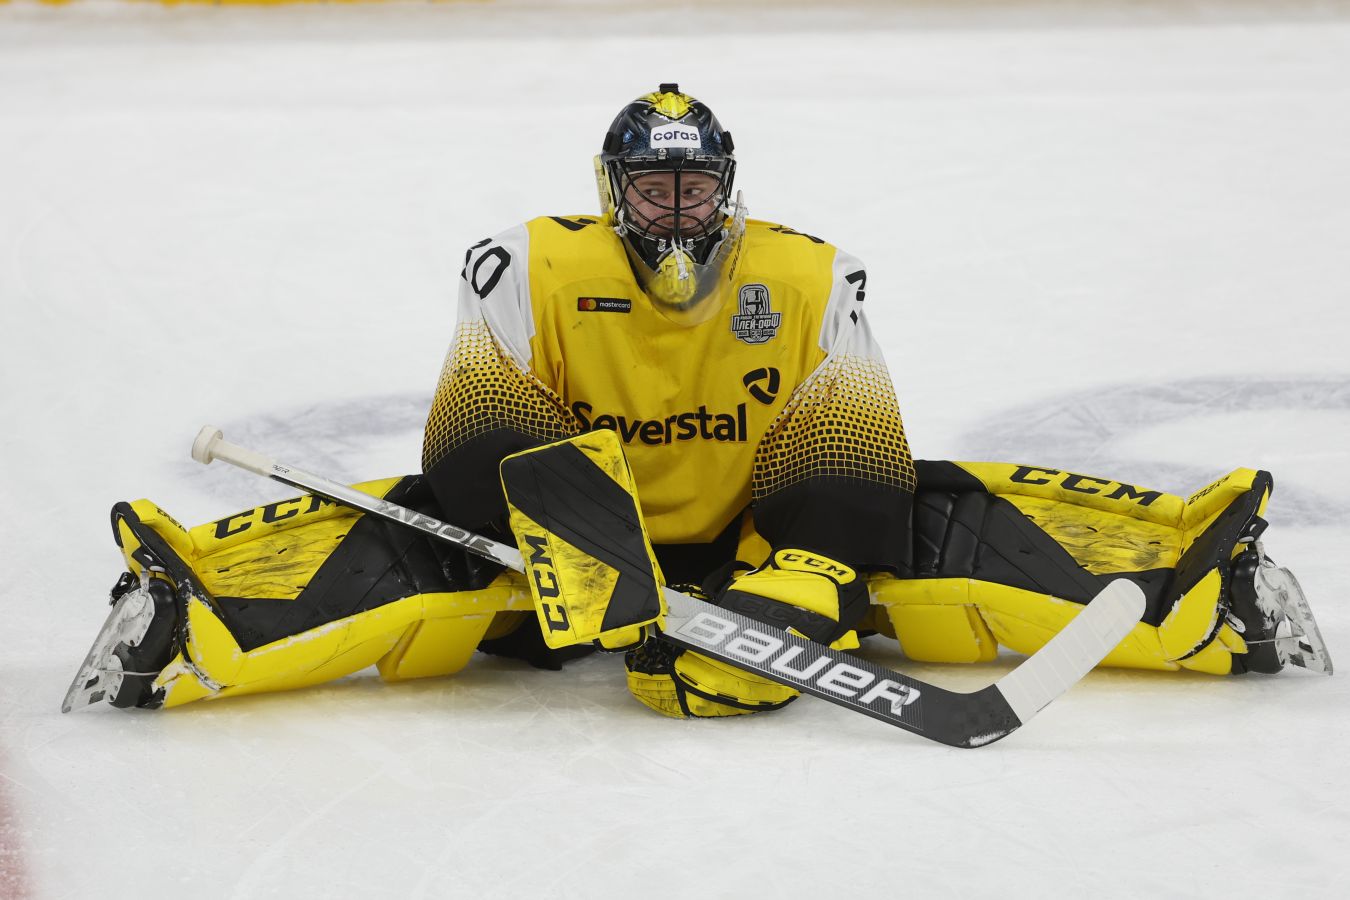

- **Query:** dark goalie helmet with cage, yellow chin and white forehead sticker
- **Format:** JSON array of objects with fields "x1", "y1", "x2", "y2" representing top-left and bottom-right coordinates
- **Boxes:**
[{"x1": 595, "y1": 84, "x2": 745, "y2": 324}]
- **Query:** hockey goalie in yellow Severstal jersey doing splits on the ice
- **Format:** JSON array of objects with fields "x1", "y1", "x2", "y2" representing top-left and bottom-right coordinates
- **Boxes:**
[{"x1": 65, "y1": 85, "x2": 1331, "y2": 716}]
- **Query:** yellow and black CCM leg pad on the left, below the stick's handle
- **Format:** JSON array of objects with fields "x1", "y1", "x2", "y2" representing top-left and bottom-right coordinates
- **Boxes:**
[{"x1": 73, "y1": 479, "x2": 531, "y2": 707}]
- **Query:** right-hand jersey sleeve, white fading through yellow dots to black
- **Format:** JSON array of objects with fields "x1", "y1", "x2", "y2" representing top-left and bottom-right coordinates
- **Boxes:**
[{"x1": 751, "y1": 251, "x2": 915, "y2": 572}]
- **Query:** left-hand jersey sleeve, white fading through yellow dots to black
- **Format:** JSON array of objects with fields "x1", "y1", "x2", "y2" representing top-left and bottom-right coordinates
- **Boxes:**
[{"x1": 423, "y1": 225, "x2": 582, "y2": 528}]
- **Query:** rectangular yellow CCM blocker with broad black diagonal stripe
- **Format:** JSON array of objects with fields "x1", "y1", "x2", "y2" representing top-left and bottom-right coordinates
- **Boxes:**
[{"x1": 501, "y1": 429, "x2": 664, "y2": 649}]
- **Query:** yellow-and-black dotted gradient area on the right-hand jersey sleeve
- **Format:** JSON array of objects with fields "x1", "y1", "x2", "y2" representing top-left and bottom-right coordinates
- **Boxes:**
[{"x1": 751, "y1": 356, "x2": 915, "y2": 499}]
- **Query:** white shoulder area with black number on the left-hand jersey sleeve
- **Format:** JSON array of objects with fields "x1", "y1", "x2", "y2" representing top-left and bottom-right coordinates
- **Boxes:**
[{"x1": 458, "y1": 224, "x2": 535, "y2": 370}]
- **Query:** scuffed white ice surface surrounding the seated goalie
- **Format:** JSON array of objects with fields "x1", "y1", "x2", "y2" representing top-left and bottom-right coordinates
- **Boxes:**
[{"x1": 0, "y1": 0, "x2": 1350, "y2": 900}]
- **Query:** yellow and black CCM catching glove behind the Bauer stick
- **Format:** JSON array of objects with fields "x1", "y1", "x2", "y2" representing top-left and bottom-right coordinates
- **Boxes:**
[{"x1": 624, "y1": 548, "x2": 869, "y2": 718}]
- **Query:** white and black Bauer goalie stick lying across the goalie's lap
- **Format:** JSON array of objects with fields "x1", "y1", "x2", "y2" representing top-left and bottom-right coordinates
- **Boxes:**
[{"x1": 192, "y1": 425, "x2": 1145, "y2": 748}]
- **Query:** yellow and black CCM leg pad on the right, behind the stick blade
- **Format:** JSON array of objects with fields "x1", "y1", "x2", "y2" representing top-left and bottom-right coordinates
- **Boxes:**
[{"x1": 869, "y1": 463, "x2": 1270, "y2": 675}]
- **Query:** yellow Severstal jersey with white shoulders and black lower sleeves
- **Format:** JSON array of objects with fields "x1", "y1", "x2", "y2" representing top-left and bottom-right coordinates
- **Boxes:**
[{"x1": 423, "y1": 216, "x2": 914, "y2": 564}]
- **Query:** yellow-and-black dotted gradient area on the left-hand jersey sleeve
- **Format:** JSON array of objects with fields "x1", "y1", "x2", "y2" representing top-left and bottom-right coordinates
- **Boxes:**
[{"x1": 423, "y1": 320, "x2": 582, "y2": 471}]
